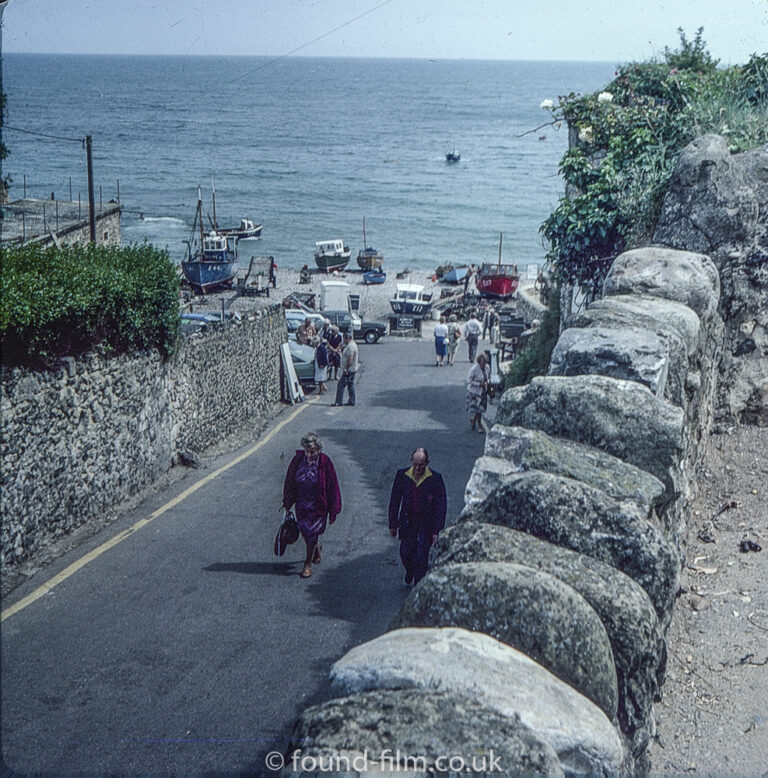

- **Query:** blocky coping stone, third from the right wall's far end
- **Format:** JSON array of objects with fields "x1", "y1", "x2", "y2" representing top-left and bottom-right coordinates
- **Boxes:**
[{"x1": 548, "y1": 327, "x2": 669, "y2": 398}]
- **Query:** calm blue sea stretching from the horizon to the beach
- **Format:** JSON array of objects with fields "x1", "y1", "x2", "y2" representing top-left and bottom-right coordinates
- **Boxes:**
[{"x1": 3, "y1": 54, "x2": 614, "y2": 270}]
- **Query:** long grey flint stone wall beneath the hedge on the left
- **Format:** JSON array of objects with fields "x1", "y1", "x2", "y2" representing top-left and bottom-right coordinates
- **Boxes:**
[{"x1": 0, "y1": 306, "x2": 286, "y2": 568}]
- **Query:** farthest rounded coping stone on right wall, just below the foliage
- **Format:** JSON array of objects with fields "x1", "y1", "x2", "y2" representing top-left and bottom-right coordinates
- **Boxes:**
[{"x1": 603, "y1": 246, "x2": 720, "y2": 322}]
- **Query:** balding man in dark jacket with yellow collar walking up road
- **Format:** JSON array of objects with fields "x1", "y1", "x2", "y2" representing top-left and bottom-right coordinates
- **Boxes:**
[{"x1": 389, "y1": 448, "x2": 447, "y2": 586}]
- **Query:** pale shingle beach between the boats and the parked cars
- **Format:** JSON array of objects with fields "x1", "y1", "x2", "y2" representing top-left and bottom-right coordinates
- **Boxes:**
[{"x1": 183, "y1": 269, "x2": 530, "y2": 322}]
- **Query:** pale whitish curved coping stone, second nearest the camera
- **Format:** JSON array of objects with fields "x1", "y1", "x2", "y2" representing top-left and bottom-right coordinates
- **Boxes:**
[{"x1": 331, "y1": 627, "x2": 625, "y2": 776}]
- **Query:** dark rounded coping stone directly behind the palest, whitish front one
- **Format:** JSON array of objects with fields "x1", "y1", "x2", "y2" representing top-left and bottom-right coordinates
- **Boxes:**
[{"x1": 392, "y1": 562, "x2": 618, "y2": 720}]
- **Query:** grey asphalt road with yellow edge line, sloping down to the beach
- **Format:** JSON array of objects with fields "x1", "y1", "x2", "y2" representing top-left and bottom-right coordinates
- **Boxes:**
[{"x1": 0, "y1": 337, "x2": 492, "y2": 775}]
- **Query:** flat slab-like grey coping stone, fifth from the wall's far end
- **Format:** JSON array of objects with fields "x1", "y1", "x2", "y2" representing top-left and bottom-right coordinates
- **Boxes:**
[{"x1": 476, "y1": 424, "x2": 664, "y2": 515}]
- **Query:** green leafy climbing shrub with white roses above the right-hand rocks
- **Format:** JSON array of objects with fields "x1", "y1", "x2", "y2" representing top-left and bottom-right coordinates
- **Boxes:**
[{"x1": 540, "y1": 28, "x2": 768, "y2": 295}]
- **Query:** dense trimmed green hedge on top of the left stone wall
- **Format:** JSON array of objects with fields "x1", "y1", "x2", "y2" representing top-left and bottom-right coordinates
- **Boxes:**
[{"x1": 0, "y1": 243, "x2": 179, "y2": 368}]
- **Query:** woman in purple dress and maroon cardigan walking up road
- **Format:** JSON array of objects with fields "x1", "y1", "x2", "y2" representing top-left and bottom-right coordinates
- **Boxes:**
[{"x1": 283, "y1": 432, "x2": 341, "y2": 578}]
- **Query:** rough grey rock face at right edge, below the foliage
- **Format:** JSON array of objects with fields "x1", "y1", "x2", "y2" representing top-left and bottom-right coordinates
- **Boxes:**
[{"x1": 653, "y1": 135, "x2": 768, "y2": 426}]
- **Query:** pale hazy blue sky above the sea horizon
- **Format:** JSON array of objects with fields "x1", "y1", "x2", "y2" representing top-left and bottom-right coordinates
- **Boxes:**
[{"x1": 2, "y1": 0, "x2": 768, "y2": 65}]
